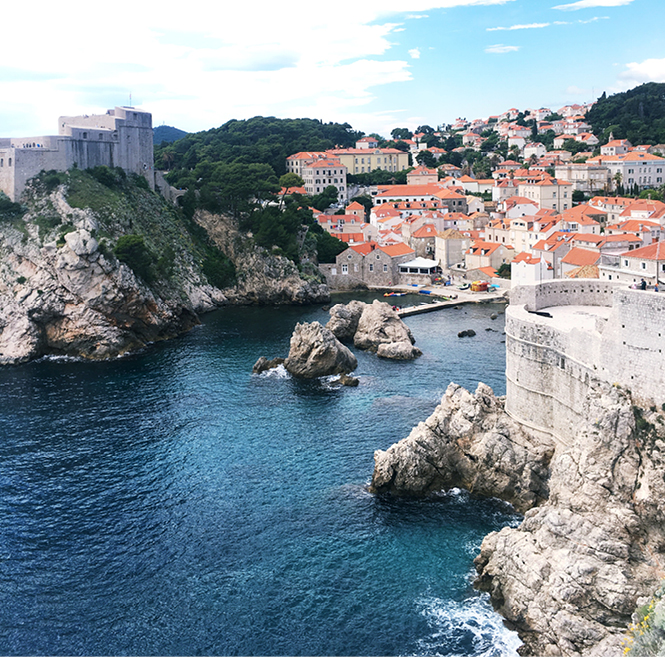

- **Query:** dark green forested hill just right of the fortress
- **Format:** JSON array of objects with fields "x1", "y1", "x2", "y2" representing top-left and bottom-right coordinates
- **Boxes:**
[{"x1": 155, "y1": 116, "x2": 364, "y2": 187}]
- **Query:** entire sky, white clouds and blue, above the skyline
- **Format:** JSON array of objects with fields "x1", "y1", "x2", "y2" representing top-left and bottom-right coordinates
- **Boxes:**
[{"x1": 0, "y1": 0, "x2": 665, "y2": 137}]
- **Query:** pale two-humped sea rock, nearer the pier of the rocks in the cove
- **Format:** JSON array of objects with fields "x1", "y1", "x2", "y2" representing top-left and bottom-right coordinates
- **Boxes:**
[{"x1": 327, "y1": 301, "x2": 422, "y2": 360}]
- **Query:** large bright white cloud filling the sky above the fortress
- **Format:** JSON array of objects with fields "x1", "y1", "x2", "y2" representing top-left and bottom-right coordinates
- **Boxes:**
[{"x1": 0, "y1": 0, "x2": 515, "y2": 135}]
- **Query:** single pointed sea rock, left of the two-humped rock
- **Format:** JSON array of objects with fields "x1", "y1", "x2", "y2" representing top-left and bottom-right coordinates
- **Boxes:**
[{"x1": 284, "y1": 322, "x2": 358, "y2": 379}]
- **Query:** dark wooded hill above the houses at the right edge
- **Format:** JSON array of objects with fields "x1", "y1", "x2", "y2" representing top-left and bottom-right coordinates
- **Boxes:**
[{"x1": 587, "y1": 82, "x2": 665, "y2": 146}]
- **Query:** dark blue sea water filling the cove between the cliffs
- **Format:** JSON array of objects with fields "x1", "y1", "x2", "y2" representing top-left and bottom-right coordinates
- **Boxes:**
[{"x1": 0, "y1": 298, "x2": 519, "y2": 655}]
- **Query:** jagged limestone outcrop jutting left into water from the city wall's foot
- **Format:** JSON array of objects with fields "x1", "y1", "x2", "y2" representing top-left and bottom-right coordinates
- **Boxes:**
[{"x1": 370, "y1": 383, "x2": 553, "y2": 511}]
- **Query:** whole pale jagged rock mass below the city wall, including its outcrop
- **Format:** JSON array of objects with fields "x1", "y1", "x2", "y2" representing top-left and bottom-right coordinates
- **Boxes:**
[{"x1": 372, "y1": 381, "x2": 665, "y2": 657}]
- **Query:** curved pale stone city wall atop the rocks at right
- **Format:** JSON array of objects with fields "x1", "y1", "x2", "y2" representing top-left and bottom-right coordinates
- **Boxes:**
[{"x1": 506, "y1": 280, "x2": 665, "y2": 444}]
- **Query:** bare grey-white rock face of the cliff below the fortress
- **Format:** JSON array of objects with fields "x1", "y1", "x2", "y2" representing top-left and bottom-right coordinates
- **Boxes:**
[{"x1": 0, "y1": 178, "x2": 226, "y2": 364}]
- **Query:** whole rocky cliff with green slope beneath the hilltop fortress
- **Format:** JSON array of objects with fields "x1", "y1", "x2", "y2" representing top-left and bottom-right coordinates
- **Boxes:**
[{"x1": 0, "y1": 170, "x2": 328, "y2": 364}]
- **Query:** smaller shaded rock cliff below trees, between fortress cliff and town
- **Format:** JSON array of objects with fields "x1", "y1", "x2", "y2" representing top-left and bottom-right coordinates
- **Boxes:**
[{"x1": 194, "y1": 211, "x2": 330, "y2": 304}]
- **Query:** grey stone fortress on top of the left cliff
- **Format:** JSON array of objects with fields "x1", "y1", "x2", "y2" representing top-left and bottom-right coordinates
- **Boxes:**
[{"x1": 0, "y1": 107, "x2": 155, "y2": 201}]
